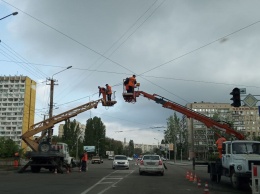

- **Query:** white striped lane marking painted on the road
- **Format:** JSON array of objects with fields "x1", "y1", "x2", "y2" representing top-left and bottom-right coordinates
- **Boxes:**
[{"x1": 81, "y1": 170, "x2": 134, "y2": 194}]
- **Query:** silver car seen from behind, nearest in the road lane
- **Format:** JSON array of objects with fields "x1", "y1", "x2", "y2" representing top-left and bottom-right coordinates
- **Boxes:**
[{"x1": 139, "y1": 155, "x2": 164, "y2": 176}]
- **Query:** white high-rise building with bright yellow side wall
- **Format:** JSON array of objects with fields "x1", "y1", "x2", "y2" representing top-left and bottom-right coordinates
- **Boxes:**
[{"x1": 0, "y1": 76, "x2": 36, "y2": 150}]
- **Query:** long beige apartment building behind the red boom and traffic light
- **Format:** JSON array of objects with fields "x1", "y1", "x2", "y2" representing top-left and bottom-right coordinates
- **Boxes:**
[{"x1": 186, "y1": 102, "x2": 260, "y2": 159}]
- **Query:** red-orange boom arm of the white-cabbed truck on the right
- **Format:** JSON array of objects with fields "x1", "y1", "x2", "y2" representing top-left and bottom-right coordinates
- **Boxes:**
[{"x1": 133, "y1": 91, "x2": 245, "y2": 140}]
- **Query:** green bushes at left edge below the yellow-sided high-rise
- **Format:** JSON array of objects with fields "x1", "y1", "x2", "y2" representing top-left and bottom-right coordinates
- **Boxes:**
[{"x1": 0, "y1": 137, "x2": 19, "y2": 158}]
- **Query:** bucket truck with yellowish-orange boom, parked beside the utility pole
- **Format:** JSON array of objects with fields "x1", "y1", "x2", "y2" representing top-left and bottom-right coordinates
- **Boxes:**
[{"x1": 19, "y1": 99, "x2": 116, "y2": 173}]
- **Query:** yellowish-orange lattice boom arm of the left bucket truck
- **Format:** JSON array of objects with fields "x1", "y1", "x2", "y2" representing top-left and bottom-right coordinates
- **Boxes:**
[{"x1": 21, "y1": 99, "x2": 103, "y2": 151}]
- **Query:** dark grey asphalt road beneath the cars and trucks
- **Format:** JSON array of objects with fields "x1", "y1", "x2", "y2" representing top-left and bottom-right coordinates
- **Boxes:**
[{"x1": 0, "y1": 160, "x2": 251, "y2": 194}]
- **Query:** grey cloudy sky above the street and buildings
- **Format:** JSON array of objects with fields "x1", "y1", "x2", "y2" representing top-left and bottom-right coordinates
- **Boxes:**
[{"x1": 0, "y1": 0, "x2": 260, "y2": 144}]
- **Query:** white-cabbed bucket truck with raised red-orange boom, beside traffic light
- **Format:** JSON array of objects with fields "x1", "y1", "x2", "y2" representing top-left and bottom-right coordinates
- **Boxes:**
[{"x1": 123, "y1": 84, "x2": 260, "y2": 188}]
